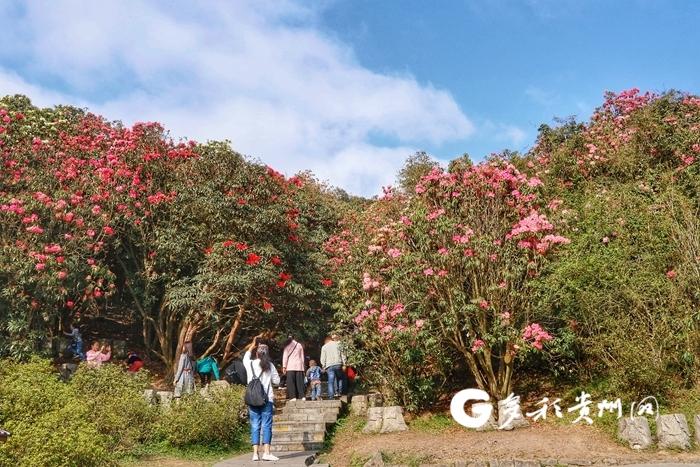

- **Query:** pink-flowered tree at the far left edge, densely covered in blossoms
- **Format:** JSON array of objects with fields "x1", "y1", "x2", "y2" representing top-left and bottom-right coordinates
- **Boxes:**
[{"x1": 0, "y1": 97, "x2": 194, "y2": 358}]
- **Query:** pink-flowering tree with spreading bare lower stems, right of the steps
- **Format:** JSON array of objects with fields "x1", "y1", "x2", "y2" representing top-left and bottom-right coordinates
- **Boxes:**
[{"x1": 327, "y1": 158, "x2": 568, "y2": 398}]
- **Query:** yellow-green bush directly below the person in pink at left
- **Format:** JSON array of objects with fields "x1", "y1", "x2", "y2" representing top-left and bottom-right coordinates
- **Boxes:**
[{"x1": 70, "y1": 365, "x2": 158, "y2": 453}]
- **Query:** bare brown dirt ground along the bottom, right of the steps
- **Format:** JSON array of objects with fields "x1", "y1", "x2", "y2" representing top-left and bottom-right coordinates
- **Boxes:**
[{"x1": 324, "y1": 425, "x2": 700, "y2": 467}]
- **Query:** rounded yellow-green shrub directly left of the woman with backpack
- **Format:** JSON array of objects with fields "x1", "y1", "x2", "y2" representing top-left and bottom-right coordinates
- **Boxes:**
[{"x1": 160, "y1": 386, "x2": 247, "y2": 448}]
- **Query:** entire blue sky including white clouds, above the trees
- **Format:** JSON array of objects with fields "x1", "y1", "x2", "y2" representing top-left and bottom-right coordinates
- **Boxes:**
[{"x1": 0, "y1": 0, "x2": 700, "y2": 195}]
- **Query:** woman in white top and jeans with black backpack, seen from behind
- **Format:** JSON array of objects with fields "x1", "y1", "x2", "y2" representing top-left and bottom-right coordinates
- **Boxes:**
[{"x1": 243, "y1": 334, "x2": 280, "y2": 461}]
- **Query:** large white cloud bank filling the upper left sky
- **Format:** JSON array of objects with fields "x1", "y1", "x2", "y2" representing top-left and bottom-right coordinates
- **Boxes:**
[{"x1": 0, "y1": 1, "x2": 476, "y2": 194}]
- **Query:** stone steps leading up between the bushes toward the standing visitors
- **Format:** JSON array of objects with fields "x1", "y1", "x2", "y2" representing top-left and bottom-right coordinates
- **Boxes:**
[{"x1": 271, "y1": 400, "x2": 343, "y2": 452}]
